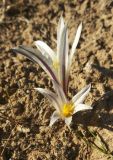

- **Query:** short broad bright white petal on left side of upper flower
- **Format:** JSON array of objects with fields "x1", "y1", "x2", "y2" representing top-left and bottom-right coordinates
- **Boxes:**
[{"x1": 35, "y1": 41, "x2": 57, "y2": 61}]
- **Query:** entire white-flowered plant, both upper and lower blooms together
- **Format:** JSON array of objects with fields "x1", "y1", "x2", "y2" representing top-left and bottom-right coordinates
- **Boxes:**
[{"x1": 13, "y1": 17, "x2": 92, "y2": 126}]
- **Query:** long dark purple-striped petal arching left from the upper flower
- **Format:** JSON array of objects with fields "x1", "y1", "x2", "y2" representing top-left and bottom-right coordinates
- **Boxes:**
[{"x1": 13, "y1": 46, "x2": 58, "y2": 81}]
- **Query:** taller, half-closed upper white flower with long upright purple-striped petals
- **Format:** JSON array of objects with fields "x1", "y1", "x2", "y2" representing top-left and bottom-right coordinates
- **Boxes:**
[{"x1": 13, "y1": 17, "x2": 82, "y2": 94}]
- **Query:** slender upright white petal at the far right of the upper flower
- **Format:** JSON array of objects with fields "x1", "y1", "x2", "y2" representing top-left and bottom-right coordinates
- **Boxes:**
[{"x1": 69, "y1": 23, "x2": 82, "y2": 65}]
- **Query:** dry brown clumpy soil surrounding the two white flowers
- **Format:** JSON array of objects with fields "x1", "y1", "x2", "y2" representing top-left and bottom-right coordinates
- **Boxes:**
[{"x1": 0, "y1": 0, "x2": 113, "y2": 160}]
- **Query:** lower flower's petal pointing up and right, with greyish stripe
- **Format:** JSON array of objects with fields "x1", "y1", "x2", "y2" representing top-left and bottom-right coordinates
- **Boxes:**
[{"x1": 72, "y1": 84, "x2": 91, "y2": 105}]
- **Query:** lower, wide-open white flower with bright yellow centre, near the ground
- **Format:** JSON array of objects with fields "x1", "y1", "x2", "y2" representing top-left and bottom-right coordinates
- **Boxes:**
[{"x1": 35, "y1": 81, "x2": 92, "y2": 126}]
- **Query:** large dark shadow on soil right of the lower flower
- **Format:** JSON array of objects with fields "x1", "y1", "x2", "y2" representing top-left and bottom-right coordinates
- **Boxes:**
[{"x1": 72, "y1": 90, "x2": 113, "y2": 131}]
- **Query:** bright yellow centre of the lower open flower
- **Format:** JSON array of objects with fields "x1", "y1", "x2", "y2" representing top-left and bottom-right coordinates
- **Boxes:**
[{"x1": 62, "y1": 103, "x2": 74, "y2": 117}]
